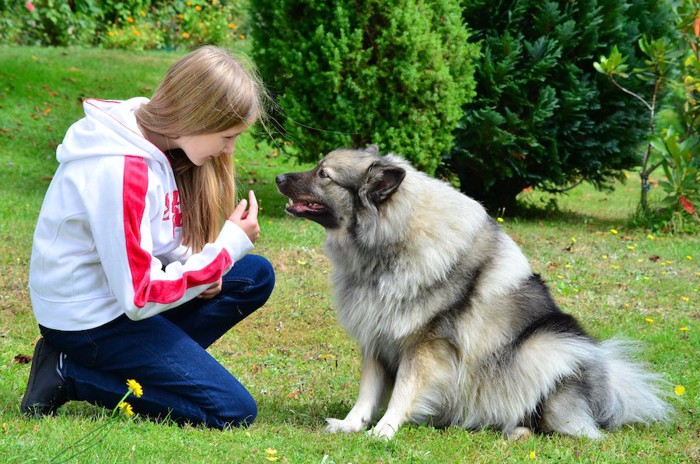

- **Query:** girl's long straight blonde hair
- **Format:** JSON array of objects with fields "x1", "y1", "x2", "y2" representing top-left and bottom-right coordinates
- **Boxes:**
[{"x1": 136, "y1": 46, "x2": 265, "y2": 252}]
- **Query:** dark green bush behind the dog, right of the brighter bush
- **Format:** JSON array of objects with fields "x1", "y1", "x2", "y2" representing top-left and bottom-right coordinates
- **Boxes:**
[{"x1": 449, "y1": 0, "x2": 670, "y2": 210}]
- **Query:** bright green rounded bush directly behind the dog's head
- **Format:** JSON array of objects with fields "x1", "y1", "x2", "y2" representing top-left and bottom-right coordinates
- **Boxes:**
[{"x1": 249, "y1": 0, "x2": 478, "y2": 172}]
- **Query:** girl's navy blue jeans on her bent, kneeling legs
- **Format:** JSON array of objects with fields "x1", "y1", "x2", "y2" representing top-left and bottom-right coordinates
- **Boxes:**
[{"x1": 40, "y1": 255, "x2": 275, "y2": 429}]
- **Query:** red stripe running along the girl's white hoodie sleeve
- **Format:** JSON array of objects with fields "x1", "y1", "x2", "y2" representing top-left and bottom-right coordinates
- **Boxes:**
[{"x1": 123, "y1": 156, "x2": 231, "y2": 308}]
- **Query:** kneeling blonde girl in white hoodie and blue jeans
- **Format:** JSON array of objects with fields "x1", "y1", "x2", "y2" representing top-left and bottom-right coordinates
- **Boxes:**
[{"x1": 21, "y1": 46, "x2": 274, "y2": 428}]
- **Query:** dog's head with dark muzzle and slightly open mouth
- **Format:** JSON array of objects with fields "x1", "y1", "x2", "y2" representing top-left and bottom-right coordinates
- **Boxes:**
[{"x1": 275, "y1": 145, "x2": 406, "y2": 229}]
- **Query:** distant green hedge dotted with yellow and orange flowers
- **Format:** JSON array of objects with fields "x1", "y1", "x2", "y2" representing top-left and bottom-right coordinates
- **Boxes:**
[{"x1": 0, "y1": 0, "x2": 247, "y2": 50}]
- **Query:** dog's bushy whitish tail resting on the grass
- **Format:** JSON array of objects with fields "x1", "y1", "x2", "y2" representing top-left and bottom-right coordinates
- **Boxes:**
[{"x1": 598, "y1": 339, "x2": 671, "y2": 429}]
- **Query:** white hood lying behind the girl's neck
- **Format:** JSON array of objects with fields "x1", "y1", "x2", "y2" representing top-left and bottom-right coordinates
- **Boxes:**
[{"x1": 56, "y1": 97, "x2": 167, "y2": 163}]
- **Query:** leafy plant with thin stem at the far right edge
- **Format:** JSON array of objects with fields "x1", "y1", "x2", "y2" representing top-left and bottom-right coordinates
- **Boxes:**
[{"x1": 594, "y1": 0, "x2": 700, "y2": 231}]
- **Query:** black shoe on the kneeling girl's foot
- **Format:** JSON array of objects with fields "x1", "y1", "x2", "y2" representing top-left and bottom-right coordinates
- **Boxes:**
[{"x1": 21, "y1": 338, "x2": 68, "y2": 418}]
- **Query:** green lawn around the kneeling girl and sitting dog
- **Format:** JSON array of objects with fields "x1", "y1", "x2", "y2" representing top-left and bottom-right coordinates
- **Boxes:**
[{"x1": 0, "y1": 47, "x2": 700, "y2": 464}]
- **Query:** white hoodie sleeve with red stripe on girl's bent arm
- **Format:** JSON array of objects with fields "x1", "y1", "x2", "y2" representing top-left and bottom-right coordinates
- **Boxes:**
[{"x1": 89, "y1": 156, "x2": 253, "y2": 320}]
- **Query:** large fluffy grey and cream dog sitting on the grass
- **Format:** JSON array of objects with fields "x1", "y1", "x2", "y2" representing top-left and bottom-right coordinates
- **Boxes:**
[{"x1": 276, "y1": 146, "x2": 668, "y2": 439}]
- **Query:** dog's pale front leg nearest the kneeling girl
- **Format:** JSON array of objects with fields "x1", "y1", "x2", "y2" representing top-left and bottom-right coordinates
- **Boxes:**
[{"x1": 326, "y1": 356, "x2": 387, "y2": 433}]
